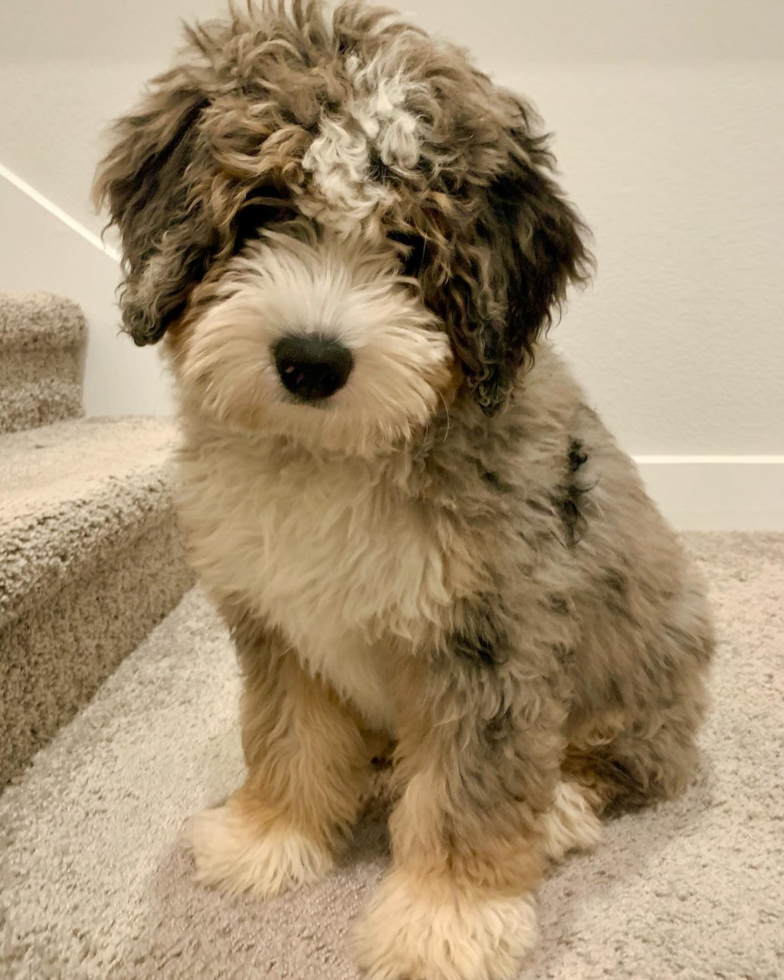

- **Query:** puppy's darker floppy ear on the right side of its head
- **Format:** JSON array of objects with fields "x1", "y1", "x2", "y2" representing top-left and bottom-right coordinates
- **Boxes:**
[{"x1": 447, "y1": 99, "x2": 593, "y2": 415}]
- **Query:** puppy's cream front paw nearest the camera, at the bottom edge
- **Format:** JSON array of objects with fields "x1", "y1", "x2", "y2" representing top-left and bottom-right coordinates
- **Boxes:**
[{"x1": 353, "y1": 871, "x2": 536, "y2": 980}]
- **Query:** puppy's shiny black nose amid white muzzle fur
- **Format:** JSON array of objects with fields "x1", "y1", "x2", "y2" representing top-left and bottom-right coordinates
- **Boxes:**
[{"x1": 273, "y1": 335, "x2": 354, "y2": 402}]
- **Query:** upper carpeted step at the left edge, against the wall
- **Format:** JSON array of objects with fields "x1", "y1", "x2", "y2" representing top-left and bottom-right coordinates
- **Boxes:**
[{"x1": 0, "y1": 292, "x2": 87, "y2": 433}]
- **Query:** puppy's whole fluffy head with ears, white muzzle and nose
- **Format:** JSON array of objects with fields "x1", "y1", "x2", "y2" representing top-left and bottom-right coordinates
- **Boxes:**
[{"x1": 96, "y1": 0, "x2": 590, "y2": 450}]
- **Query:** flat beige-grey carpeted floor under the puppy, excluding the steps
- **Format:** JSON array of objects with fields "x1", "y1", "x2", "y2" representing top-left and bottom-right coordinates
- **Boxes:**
[{"x1": 0, "y1": 534, "x2": 784, "y2": 980}]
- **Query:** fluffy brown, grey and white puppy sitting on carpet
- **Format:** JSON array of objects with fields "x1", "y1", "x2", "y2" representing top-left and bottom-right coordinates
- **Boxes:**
[{"x1": 96, "y1": 0, "x2": 713, "y2": 980}]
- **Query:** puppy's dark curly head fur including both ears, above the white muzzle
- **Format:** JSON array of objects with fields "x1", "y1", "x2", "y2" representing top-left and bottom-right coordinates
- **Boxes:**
[{"x1": 96, "y1": 0, "x2": 590, "y2": 413}]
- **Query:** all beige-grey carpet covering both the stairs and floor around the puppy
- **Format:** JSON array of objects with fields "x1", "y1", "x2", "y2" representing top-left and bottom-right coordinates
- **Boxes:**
[{"x1": 0, "y1": 295, "x2": 784, "y2": 980}]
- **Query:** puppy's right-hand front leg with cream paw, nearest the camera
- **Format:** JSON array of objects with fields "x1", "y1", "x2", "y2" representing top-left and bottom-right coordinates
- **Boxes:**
[{"x1": 354, "y1": 635, "x2": 564, "y2": 980}]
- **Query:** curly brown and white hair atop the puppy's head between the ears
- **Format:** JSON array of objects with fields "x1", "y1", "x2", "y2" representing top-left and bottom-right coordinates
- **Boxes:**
[{"x1": 196, "y1": 4, "x2": 517, "y2": 232}]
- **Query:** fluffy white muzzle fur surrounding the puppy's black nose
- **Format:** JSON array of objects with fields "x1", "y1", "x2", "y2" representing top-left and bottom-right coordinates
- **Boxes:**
[{"x1": 175, "y1": 232, "x2": 452, "y2": 454}]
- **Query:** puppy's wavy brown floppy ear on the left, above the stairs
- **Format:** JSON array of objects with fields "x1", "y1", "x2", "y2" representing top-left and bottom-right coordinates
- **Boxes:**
[{"x1": 93, "y1": 69, "x2": 217, "y2": 345}]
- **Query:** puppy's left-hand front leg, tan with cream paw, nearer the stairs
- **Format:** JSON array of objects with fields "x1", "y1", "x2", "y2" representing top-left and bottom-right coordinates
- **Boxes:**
[{"x1": 188, "y1": 624, "x2": 368, "y2": 898}]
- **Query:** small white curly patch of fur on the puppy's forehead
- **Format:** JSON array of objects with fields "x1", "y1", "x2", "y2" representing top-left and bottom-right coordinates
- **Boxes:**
[{"x1": 299, "y1": 56, "x2": 420, "y2": 233}]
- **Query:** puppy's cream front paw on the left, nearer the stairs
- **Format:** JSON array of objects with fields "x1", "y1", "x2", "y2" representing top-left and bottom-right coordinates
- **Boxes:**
[{"x1": 186, "y1": 800, "x2": 333, "y2": 898}]
